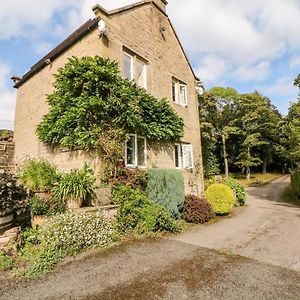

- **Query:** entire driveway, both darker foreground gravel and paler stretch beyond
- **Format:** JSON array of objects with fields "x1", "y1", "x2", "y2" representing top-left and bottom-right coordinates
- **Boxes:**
[{"x1": 0, "y1": 177, "x2": 300, "y2": 300}]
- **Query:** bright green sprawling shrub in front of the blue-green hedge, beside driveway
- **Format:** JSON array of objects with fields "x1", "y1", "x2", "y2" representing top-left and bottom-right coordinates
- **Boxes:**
[{"x1": 115, "y1": 186, "x2": 181, "y2": 234}]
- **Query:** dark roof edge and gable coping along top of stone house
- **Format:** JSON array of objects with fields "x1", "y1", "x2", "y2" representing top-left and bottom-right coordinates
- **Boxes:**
[{"x1": 14, "y1": 0, "x2": 200, "y2": 88}]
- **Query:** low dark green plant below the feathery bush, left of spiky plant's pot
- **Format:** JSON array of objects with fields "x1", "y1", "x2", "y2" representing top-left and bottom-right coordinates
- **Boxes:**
[{"x1": 29, "y1": 196, "x2": 66, "y2": 216}]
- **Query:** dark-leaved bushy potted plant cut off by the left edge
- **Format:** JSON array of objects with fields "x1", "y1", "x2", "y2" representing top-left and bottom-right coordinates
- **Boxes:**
[{"x1": 0, "y1": 170, "x2": 28, "y2": 231}]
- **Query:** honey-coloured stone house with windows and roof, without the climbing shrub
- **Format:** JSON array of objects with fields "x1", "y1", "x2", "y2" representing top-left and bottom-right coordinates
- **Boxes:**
[{"x1": 14, "y1": 0, "x2": 203, "y2": 194}]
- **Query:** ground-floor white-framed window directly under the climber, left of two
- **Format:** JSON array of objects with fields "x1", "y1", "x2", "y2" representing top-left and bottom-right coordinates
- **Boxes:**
[{"x1": 125, "y1": 134, "x2": 147, "y2": 167}]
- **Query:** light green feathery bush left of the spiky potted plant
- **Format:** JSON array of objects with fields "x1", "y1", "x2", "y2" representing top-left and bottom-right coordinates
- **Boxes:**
[{"x1": 20, "y1": 159, "x2": 60, "y2": 192}]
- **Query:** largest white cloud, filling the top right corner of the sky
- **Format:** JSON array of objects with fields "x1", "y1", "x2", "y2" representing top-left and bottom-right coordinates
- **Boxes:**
[{"x1": 169, "y1": 0, "x2": 300, "y2": 64}]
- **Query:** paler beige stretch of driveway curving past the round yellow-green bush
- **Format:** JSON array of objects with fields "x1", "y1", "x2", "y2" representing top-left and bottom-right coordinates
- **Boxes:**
[{"x1": 173, "y1": 176, "x2": 300, "y2": 272}]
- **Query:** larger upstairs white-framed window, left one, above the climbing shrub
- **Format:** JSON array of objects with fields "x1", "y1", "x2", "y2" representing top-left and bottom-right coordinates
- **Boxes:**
[{"x1": 123, "y1": 52, "x2": 147, "y2": 89}]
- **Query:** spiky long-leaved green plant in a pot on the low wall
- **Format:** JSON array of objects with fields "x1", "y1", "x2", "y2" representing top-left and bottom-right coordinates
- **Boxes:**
[{"x1": 52, "y1": 164, "x2": 96, "y2": 209}]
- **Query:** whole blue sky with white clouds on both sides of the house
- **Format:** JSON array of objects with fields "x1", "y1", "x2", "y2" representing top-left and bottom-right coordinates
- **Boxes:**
[{"x1": 0, "y1": 0, "x2": 300, "y2": 128}]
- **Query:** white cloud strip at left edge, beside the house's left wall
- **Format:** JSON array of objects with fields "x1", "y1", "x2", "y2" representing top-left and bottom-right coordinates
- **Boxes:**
[{"x1": 0, "y1": 62, "x2": 16, "y2": 129}]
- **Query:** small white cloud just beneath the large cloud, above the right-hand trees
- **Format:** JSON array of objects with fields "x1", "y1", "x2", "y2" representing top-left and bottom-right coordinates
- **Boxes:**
[{"x1": 234, "y1": 61, "x2": 271, "y2": 81}]
